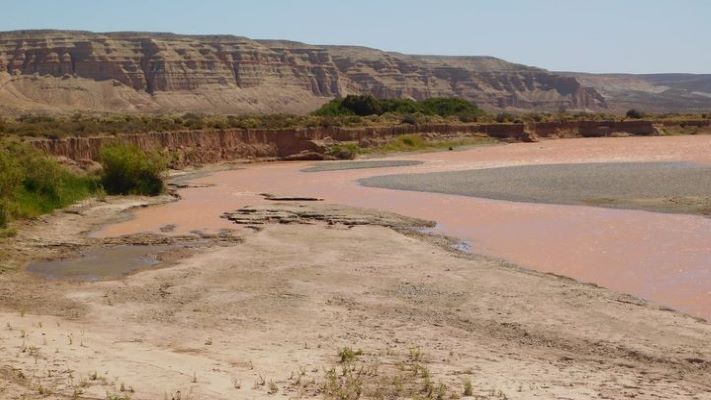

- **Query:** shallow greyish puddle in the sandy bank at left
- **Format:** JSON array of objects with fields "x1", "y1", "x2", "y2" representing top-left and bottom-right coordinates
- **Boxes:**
[{"x1": 27, "y1": 245, "x2": 174, "y2": 281}]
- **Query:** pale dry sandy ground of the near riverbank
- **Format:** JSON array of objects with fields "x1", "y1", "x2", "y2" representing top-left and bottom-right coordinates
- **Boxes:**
[{"x1": 0, "y1": 200, "x2": 711, "y2": 399}]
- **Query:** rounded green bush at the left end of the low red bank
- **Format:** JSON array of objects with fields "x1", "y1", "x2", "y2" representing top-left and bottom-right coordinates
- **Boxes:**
[{"x1": 101, "y1": 144, "x2": 168, "y2": 196}]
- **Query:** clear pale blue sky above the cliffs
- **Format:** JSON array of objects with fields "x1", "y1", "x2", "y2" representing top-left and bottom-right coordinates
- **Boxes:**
[{"x1": 0, "y1": 0, "x2": 711, "y2": 73}]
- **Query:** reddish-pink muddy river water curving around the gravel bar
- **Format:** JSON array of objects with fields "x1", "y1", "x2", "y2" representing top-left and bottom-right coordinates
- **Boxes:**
[{"x1": 98, "y1": 136, "x2": 711, "y2": 319}]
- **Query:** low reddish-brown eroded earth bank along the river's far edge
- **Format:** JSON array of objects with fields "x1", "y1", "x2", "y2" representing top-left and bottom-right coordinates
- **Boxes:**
[{"x1": 27, "y1": 120, "x2": 711, "y2": 166}]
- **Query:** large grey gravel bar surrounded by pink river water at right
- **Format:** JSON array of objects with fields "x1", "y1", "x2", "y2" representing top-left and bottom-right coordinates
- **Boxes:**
[{"x1": 359, "y1": 162, "x2": 711, "y2": 215}]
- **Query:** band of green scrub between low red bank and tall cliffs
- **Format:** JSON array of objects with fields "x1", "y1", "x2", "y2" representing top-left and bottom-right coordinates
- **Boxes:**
[{"x1": 0, "y1": 110, "x2": 711, "y2": 138}]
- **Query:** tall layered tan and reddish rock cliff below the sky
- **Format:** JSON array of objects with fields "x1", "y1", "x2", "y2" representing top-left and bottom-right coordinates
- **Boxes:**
[{"x1": 0, "y1": 31, "x2": 607, "y2": 113}]
